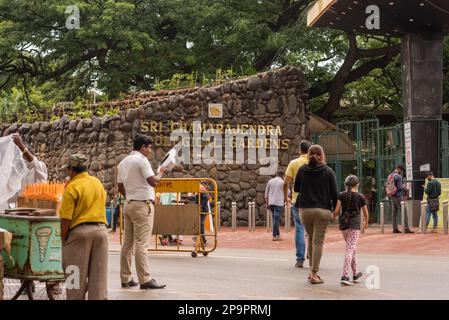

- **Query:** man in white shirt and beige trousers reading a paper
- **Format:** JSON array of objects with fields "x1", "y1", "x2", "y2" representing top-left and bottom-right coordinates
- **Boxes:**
[{"x1": 117, "y1": 135, "x2": 165, "y2": 289}]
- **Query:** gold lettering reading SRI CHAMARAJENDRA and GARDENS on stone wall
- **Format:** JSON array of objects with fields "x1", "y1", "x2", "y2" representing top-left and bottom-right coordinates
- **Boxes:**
[{"x1": 140, "y1": 121, "x2": 289, "y2": 175}]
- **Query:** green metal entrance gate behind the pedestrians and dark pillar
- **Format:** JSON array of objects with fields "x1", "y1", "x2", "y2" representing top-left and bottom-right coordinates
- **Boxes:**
[{"x1": 312, "y1": 119, "x2": 449, "y2": 223}]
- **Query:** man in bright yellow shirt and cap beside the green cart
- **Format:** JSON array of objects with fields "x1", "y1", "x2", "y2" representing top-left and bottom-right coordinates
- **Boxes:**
[{"x1": 59, "y1": 154, "x2": 108, "y2": 300}]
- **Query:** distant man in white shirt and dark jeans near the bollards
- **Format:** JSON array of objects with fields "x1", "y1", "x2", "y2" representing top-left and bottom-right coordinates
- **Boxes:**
[{"x1": 265, "y1": 171, "x2": 284, "y2": 241}]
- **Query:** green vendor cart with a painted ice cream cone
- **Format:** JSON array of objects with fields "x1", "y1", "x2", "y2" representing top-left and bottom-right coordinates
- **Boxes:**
[{"x1": 0, "y1": 212, "x2": 65, "y2": 300}]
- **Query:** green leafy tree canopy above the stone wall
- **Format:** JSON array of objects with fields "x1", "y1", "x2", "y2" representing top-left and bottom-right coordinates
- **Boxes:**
[{"x1": 0, "y1": 0, "x2": 449, "y2": 119}]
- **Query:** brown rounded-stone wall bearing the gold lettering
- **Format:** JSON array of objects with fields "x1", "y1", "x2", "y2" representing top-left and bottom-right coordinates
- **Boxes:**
[{"x1": 0, "y1": 67, "x2": 309, "y2": 225}]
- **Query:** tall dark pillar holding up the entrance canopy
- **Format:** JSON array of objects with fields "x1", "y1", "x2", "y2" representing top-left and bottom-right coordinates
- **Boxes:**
[{"x1": 401, "y1": 33, "x2": 443, "y2": 200}]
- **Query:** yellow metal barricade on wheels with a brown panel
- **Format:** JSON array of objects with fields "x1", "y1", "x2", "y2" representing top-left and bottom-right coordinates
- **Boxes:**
[{"x1": 120, "y1": 178, "x2": 218, "y2": 258}]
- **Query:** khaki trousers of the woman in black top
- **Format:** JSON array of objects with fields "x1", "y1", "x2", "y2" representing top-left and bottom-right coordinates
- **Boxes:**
[{"x1": 300, "y1": 208, "x2": 332, "y2": 272}]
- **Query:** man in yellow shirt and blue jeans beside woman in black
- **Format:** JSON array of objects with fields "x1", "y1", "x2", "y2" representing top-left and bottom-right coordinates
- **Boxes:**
[{"x1": 284, "y1": 140, "x2": 311, "y2": 268}]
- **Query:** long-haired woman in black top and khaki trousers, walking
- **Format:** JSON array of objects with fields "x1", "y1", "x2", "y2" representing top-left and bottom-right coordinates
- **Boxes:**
[{"x1": 294, "y1": 145, "x2": 338, "y2": 284}]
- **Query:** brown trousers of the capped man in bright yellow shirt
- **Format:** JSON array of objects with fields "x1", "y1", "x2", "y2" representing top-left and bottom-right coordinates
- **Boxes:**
[{"x1": 62, "y1": 225, "x2": 108, "y2": 300}]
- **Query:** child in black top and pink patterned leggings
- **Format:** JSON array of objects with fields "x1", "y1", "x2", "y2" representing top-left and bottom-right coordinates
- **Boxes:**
[{"x1": 334, "y1": 175, "x2": 368, "y2": 285}]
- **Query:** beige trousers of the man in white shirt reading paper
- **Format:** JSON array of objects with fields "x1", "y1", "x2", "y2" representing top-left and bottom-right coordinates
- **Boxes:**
[{"x1": 120, "y1": 201, "x2": 154, "y2": 284}]
